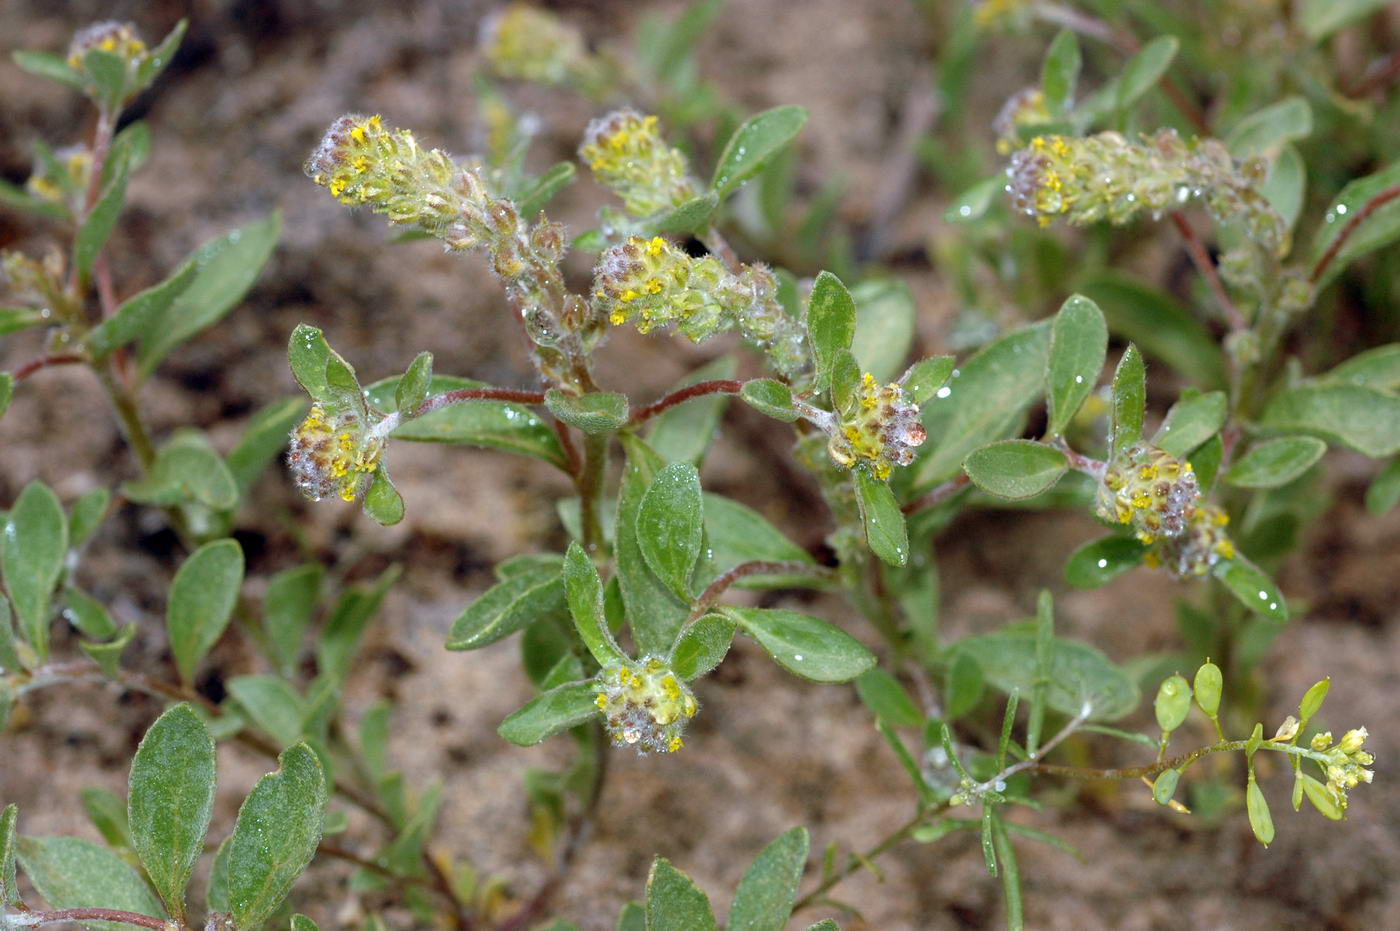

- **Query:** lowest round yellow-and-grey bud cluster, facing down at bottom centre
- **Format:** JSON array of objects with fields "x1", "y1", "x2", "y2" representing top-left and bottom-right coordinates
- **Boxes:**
[{"x1": 594, "y1": 657, "x2": 700, "y2": 753}]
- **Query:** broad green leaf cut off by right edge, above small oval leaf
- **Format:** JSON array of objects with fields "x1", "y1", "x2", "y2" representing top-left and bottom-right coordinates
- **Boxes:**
[{"x1": 1259, "y1": 385, "x2": 1400, "y2": 459}]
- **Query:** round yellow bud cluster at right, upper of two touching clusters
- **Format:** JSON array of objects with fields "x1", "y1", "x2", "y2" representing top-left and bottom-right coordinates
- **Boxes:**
[{"x1": 1098, "y1": 442, "x2": 1201, "y2": 545}]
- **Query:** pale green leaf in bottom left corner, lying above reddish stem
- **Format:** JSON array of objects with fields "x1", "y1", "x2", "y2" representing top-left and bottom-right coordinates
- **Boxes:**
[{"x1": 15, "y1": 837, "x2": 165, "y2": 931}]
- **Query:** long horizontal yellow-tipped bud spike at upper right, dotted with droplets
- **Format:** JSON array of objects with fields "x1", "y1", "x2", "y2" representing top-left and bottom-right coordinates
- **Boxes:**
[{"x1": 1007, "y1": 129, "x2": 1288, "y2": 253}]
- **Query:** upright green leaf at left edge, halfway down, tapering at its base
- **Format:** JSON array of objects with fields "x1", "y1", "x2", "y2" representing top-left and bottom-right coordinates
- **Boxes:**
[{"x1": 0, "y1": 480, "x2": 69, "y2": 662}]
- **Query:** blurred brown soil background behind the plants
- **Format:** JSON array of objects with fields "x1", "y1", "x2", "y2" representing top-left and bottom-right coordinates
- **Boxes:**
[{"x1": 0, "y1": 0, "x2": 1400, "y2": 931}]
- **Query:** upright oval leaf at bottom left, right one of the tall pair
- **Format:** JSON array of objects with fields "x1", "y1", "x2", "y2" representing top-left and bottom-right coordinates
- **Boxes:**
[{"x1": 228, "y1": 743, "x2": 326, "y2": 928}]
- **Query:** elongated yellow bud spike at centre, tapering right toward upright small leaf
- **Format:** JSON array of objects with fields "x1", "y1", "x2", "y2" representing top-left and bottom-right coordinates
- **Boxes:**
[{"x1": 592, "y1": 237, "x2": 806, "y2": 375}]
